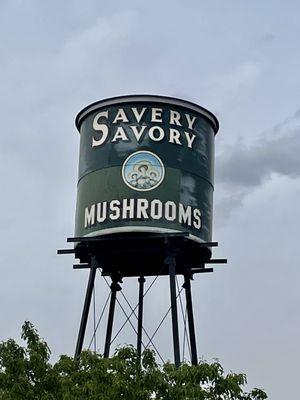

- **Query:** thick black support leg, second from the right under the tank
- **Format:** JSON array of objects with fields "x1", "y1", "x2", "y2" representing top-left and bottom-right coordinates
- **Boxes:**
[{"x1": 166, "y1": 252, "x2": 180, "y2": 367}]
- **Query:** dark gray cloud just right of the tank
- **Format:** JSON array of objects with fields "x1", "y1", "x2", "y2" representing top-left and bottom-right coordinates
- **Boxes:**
[{"x1": 217, "y1": 110, "x2": 300, "y2": 189}]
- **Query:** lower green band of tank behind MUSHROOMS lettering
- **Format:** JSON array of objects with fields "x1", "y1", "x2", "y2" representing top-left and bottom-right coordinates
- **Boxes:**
[{"x1": 75, "y1": 167, "x2": 213, "y2": 241}]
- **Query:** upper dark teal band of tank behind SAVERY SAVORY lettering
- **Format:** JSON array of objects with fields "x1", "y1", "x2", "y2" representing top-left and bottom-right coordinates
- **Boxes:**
[{"x1": 79, "y1": 104, "x2": 214, "y2": 182}]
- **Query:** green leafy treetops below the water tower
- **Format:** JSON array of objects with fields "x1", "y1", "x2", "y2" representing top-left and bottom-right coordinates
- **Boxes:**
[{"x1": 0, "y1": 322, "x2": 267, "y2": 400}]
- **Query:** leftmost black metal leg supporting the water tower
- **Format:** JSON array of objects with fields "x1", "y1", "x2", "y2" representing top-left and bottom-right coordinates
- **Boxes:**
[{"x1": 74, "y1": 257, "x2": 97, "y2": 358}]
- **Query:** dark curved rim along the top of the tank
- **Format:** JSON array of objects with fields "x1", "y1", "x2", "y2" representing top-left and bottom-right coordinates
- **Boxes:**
[{"x1": 75, "y1": 94, "x2": 219, "y2": 135}]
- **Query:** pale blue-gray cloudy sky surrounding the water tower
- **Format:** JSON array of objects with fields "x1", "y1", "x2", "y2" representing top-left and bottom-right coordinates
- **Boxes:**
[{"x1": 0, "y1": 0, "x2": 300, "y2": 400}]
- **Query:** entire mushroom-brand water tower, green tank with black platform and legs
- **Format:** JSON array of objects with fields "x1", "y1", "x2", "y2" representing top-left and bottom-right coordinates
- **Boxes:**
[{"x1": 58, "y1": 95, "x2": 226, "y2": 365}]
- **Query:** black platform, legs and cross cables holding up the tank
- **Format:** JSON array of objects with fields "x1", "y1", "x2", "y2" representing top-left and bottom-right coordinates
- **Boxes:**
[{"x1": 58, "y1": 233, "x2": 227, "y2": 366}]
